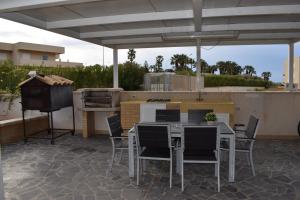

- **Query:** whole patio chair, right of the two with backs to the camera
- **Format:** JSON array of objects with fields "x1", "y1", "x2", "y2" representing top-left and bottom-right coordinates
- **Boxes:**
[{"x1": 180, "y1": 126, "x2": 220, "y2": 192}]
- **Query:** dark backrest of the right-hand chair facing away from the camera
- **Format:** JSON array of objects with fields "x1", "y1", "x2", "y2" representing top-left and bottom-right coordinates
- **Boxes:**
[{"x1": 181, "y1": 126, "x2": 220, "y2": 152}]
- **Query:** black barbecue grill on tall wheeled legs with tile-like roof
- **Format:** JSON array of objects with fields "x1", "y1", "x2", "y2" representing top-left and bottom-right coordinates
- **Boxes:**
[{"x1": 19, "y1": 74, "x2": 75, "y2": 144}]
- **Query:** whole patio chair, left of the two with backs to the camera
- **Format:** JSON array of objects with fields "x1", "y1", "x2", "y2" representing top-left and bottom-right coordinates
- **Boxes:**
[{"x1": 135, "y1": 124, "x2": 173, "y2": 188}]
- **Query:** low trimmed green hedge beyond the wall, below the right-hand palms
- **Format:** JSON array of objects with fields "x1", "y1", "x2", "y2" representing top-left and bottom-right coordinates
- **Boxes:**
[{"x1": 204, "y1": 75, "x2": 272, "y2": 88}]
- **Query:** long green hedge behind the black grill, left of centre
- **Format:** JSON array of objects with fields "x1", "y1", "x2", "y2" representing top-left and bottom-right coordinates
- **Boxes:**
[{"x1": 0, "y1": 61, "x2": 146, "y2": 94}]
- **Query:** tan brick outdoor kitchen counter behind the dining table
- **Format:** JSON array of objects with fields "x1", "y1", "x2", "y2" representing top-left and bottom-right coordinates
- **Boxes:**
[{"x1": 121, "y1": 100, "x2": 235, "y2": 129}]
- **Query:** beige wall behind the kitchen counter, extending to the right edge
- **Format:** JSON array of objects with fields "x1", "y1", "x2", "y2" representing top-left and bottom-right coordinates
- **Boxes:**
[{"x1": 121, "y1": 91, "x2": 300, "y2": 138}]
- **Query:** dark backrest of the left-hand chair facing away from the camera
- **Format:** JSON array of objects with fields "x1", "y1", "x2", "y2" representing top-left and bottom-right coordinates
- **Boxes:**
[{"x1": 135, "y1": 123, "x2": 171, "y2": 149}]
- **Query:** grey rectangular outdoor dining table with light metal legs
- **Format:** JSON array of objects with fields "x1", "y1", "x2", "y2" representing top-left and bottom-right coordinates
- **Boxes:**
[{"x1": 128, "y1": 122, "x2": 235, "y2": 182}]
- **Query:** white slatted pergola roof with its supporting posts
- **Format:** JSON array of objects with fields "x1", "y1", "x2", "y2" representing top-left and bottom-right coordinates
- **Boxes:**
[{"x1": 0, "y1": 0, "x2": 300, "y2": 89}]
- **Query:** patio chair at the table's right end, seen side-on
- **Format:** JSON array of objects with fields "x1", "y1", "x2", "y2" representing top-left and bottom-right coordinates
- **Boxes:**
[{"x1": 221, "y1": 115, "x2": 259, "y2": 176}]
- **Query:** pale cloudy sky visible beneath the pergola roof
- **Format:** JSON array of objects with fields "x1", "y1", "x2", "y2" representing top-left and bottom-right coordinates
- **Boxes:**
[{"x1": 0, "y1": 18, "x2": 300, "y2": 82}]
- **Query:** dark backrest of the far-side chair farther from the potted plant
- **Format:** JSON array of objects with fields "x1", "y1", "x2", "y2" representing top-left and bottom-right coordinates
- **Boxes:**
[{"x1": 155, "y1": 109, "x2": 180, "y2": 122}]
